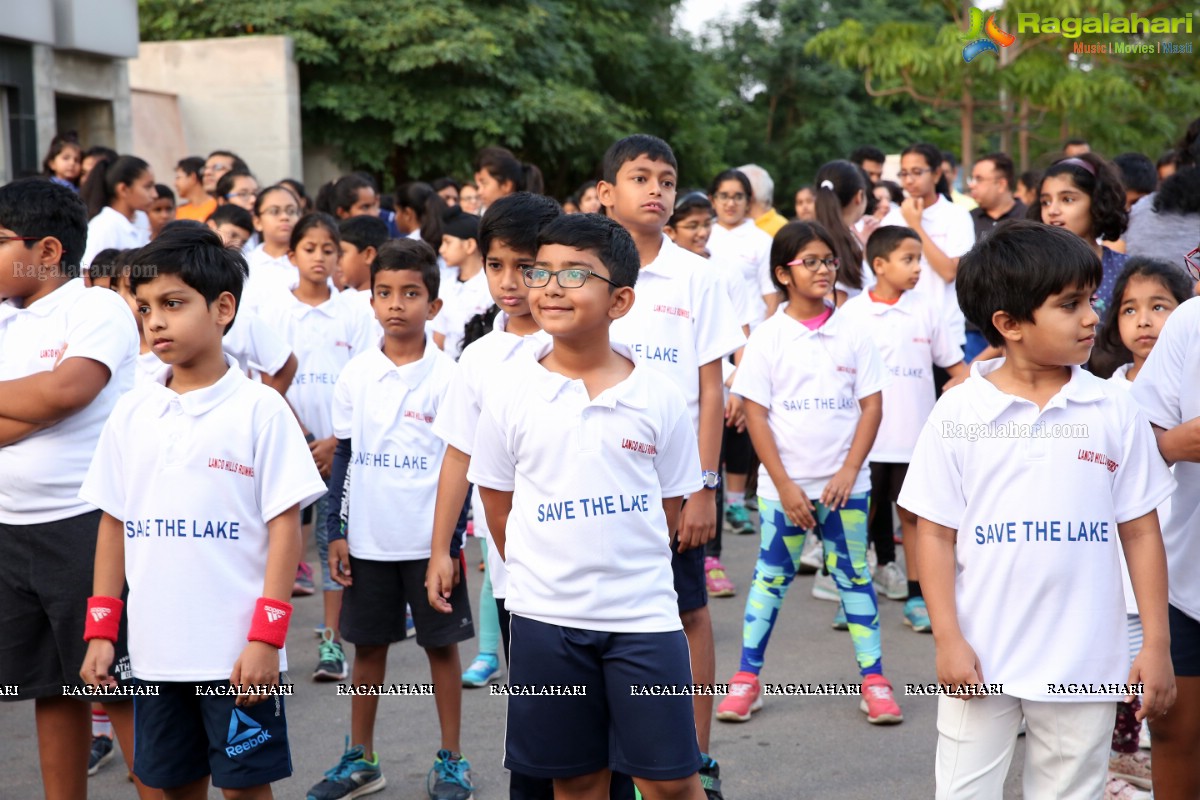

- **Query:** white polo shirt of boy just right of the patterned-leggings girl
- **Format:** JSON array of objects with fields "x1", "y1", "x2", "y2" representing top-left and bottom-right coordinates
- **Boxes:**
[{"x1": 838, "y1": 291, "x2": 962, "y2": 464}]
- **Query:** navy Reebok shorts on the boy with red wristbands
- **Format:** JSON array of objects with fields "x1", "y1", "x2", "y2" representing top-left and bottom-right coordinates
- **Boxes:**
[{"x1": 133, "y1": 676, "x2": 292, "y2": 789}]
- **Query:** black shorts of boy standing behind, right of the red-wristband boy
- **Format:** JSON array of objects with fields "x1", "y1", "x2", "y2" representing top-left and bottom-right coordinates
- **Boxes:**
[{"x1": 338, "y1": 555, "x2": 475, "y2": 648}]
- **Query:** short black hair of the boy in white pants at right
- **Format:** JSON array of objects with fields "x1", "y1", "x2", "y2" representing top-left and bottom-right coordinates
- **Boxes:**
[{"x1": 955, "y1": 219, "x2": 1104, "y2": 347}]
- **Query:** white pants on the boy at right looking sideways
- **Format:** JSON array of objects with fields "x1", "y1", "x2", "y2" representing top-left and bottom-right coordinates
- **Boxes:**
[{"x1": 936, "y1": 694, "x2": 1116, "y2": 800}]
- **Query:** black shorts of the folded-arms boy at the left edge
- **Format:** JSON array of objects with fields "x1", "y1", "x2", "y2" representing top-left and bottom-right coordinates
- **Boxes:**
[{"x1": 0, "y1": 511, "x2": 132, "y2": 703}]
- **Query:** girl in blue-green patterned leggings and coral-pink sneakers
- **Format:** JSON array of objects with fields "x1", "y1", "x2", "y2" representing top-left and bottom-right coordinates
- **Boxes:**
[{"x1": 716, "y1": 222, "x2": 904, "y2": 723}]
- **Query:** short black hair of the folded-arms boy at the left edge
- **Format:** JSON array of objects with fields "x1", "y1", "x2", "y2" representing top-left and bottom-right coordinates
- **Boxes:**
[{"x1": 0, "y1": 178, "x2": 88, "y2": 273}]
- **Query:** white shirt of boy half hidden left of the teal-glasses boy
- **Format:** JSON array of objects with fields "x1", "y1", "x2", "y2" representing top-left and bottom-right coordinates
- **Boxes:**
[{"x1": 433, "y1": 311, "x2": 550, "y2": 600}]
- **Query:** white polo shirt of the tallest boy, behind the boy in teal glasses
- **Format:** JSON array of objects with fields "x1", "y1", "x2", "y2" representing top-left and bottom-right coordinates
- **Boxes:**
[{"x1": 610, "y1": 231, "x2": 744, "y2": 429}]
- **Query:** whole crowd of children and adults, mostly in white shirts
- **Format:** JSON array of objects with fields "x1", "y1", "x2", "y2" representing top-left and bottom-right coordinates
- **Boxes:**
[{"x1": 7, "y1": 119, "x2": 1200, "y2": 800}]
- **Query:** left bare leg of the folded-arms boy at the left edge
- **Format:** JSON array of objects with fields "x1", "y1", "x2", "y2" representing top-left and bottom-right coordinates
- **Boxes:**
[{"x1": 34, "y1": 697, "x2": 91, "y2": 800}]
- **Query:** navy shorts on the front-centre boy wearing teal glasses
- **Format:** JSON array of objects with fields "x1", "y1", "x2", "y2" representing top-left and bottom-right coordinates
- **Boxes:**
[{"x1": 504, "y1": 618, "x2": 703, "y2": 781}]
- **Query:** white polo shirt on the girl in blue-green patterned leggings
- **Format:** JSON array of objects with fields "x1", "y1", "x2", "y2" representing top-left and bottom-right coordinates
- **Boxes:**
[{"x1": 731, "y1": 302, "x2": 889, "y2": 500}]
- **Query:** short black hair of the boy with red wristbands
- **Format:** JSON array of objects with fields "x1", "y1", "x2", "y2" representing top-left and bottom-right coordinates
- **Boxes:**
[{"x1": 128, "y1": 222, "x2": 250, "y2": 332}]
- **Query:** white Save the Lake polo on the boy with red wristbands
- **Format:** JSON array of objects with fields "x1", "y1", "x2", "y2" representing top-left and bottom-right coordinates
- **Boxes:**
[{"x1": 79, "y1": 356, "x2": 325, "y2": 681}]
